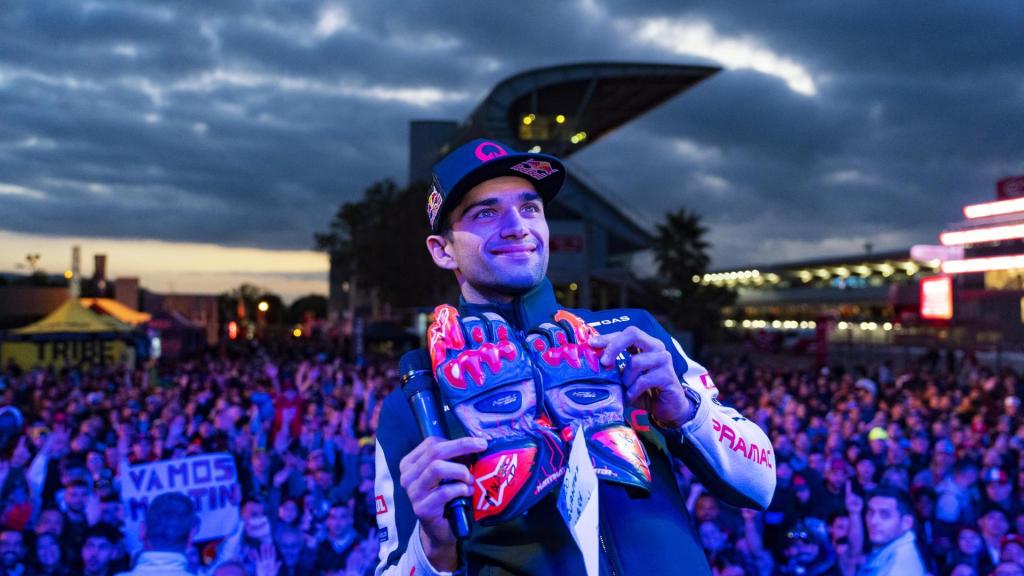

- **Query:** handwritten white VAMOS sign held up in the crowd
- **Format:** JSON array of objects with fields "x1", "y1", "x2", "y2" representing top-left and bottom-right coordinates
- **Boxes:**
[{"x1": 121, "y1": 453, "x2": 242, "y2": 541}]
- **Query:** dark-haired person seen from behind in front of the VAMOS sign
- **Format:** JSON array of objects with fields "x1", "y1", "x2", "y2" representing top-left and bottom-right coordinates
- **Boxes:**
[{"x1": 121, "y1": 492, "x2": 197, "y2": 576}]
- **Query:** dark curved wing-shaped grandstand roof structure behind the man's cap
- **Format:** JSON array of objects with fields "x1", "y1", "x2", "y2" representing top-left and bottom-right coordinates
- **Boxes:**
[{"x1": 437, "y1": 61, "x2": 721, "y2": 253}]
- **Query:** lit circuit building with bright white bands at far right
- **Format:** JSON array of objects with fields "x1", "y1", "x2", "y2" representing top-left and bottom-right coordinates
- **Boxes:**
[{"x1": 708, "y1": 177, "x2": 1024, "y2": 352}]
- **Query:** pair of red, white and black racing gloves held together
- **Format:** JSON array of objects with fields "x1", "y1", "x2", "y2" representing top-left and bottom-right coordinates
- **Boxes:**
[{"x1": 427, "y1": 304, "x2": 651, "y2": 526}]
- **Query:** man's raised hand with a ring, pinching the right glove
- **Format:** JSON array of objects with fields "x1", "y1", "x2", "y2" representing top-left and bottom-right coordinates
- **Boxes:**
[{"x1": 590, "y1": 326, "x2": 690, "y2": 428}]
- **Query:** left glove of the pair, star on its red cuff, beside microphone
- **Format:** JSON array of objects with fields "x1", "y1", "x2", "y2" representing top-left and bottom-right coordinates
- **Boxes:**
[{"x1": 428, "y1": 305, "x2": 565, "y2": 525}]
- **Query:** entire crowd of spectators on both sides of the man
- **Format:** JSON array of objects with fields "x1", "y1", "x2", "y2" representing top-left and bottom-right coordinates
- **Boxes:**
[{"x1": 0, "y1": 342, "x2": 1024, "y2": 576}]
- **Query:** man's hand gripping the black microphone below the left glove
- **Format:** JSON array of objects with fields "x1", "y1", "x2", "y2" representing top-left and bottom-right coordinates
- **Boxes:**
[{"x1": 398, "y1": 437, "x2": 487, "y2": 572}]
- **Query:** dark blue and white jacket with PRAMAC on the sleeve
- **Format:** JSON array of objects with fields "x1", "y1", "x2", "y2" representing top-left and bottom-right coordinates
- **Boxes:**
[{"x1": 375, "y1": 281, "x2": 775, "y2": 576}]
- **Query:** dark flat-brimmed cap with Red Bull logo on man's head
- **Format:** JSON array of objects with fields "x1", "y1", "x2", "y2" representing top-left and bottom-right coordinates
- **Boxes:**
[{"x1": 427, "y1": 138, "x2": 565, "y2": 233}]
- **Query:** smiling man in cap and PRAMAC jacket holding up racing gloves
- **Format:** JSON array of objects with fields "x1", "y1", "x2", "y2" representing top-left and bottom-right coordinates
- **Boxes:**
[{"x1": 376, "y1": 140, "x2": 775, "y2": 576}]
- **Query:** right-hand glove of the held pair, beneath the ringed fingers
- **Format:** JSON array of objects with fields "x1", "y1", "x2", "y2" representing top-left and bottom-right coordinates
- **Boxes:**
[{"x1": 526, "y1": 311, "x2": 651, "y2": 490}]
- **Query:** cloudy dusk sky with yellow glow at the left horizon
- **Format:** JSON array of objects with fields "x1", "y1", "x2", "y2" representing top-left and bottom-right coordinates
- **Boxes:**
[{"x1": 0, "y1": 0, "x2": 1024, "y2": 297}]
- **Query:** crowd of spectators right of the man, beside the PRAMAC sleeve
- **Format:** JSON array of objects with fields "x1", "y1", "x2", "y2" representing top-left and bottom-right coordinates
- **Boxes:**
[{"x1": 678, "y1": 355, "x2": 1024, "y2": 576}]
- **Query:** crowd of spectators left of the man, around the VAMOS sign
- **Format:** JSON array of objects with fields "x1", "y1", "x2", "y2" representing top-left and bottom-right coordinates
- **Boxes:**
[{"x1": 0, "y1": 344, "x2": 389, "y2": 576}]
